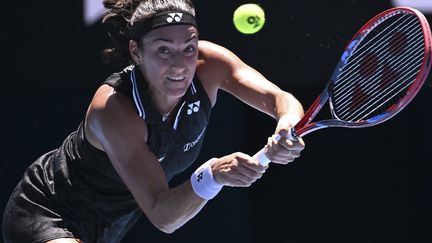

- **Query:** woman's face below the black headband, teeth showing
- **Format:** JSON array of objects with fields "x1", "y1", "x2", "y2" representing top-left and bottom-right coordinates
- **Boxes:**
[{"x1": 138, "y1": 25, "x2": 198, "y2": 98}]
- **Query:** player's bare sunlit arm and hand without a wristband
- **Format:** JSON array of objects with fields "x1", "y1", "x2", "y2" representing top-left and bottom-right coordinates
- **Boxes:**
[{"x1": 197, "y1": 41, "x2": 304, "y2": 163}]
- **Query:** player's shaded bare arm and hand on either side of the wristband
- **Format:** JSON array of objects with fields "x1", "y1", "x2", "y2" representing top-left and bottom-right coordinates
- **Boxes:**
[{"x1": 85, "y1": 85, "x2": 265, "y2": 233}]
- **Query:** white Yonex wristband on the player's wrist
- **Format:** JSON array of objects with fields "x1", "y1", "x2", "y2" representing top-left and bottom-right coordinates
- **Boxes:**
[{"x1": 191, "y1": 159, "x2": 223, "y2": 200}]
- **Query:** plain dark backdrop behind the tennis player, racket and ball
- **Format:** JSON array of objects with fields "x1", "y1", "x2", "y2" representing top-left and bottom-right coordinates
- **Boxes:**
[{"x1": 0, "y1": 0, "x2": 432, "y2": 243}]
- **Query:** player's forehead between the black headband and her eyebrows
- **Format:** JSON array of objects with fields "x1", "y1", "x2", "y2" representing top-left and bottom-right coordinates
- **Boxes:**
[{"x1": 143, "y1": 25, "x2": 198, "y2": 43}]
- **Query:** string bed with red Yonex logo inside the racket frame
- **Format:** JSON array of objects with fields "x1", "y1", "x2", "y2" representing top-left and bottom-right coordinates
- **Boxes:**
[{"x1": 333, "y1": 12, "x2": 424, "y2": 121}]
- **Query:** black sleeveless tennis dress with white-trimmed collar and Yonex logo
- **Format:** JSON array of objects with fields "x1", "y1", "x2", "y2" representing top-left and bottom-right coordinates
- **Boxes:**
[{"x1": 3, "y1": 66, "x2": 212, "y2": 243}]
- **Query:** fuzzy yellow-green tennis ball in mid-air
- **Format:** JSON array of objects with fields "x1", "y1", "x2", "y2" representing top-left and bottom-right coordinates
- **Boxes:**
[{"x1": 233, "y1": 3, "x2": 265, "y2": 34}]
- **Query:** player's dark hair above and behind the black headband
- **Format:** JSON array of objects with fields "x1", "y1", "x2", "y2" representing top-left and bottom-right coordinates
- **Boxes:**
[{"x1": 102, "y1": 0, "x2": 195, "y2": 65}]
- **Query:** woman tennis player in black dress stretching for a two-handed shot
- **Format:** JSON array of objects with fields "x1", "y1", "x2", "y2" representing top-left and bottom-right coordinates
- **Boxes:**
[{"x1": 3, "y1": 0, "x2": 304, "y2": 243}]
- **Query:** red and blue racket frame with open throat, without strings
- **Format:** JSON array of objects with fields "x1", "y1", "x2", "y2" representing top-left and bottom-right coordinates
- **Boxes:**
[{"x1": 290, "y1": 6, "x2": 432, "y2": 139}]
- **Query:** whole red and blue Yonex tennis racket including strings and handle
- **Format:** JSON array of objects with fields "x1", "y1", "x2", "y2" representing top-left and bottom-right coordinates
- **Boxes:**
[{"x1": 254, "y1": 7, "x2": 432, "y2": 165}]
